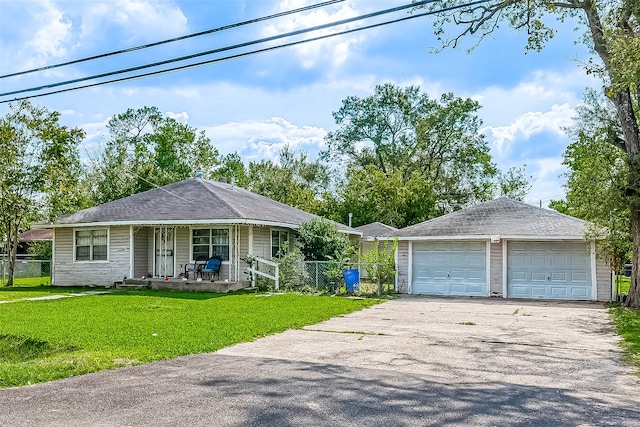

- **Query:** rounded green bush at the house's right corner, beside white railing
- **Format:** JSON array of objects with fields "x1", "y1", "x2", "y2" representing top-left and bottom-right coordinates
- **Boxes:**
[{"x1": 297, "y1": 218, "x2": 354, "y2": 262}]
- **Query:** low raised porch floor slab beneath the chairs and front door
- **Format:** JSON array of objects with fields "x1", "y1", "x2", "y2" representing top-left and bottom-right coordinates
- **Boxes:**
[{"x1": 119, "y1": 278, "x2": 251, "y2": 293}]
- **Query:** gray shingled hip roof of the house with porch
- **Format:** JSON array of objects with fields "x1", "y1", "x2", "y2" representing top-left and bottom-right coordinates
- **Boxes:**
[{"x1": 53, "y1": 178, "x2": 358, "y2": 234}]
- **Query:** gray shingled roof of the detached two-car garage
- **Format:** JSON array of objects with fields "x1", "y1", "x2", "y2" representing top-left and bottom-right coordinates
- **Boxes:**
[{"x1": 391, "y1": 197, "x2": 590, "y2": 238}]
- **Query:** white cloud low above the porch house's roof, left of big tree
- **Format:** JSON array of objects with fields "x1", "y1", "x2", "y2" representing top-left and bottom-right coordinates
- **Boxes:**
[{"x1": 204, "y1": 117, "x2": 327, "y2": 161}]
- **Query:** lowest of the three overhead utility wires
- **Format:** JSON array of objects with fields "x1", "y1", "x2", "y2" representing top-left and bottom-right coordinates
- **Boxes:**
[{"x1": 0, "y1": 0, "x2": 492, "y2": 104}]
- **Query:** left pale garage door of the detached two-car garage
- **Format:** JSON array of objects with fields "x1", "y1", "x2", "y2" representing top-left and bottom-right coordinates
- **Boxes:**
[{"x1": 412, "y1": 242, "x2": 489, "y2": 296}]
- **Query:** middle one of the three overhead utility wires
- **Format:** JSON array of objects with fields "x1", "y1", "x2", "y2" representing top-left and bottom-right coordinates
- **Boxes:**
[{"x1": 0, "y1": 0, "x2": 437, "y2": 96}]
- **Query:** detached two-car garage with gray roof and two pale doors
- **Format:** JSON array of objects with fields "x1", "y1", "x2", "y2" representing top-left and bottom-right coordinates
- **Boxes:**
[{"x1": 387, "y1": 197, "x2": 612, "y2": 301}]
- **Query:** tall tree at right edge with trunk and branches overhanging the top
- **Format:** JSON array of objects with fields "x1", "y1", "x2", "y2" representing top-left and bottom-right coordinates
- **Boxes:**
[{"x1": 416, "y1": 0, "x2": 640, "y2": 309}]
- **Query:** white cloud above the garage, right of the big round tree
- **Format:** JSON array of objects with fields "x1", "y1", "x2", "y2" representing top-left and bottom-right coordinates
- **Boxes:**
[{"x1": 480, "y1": 104, "x2": 575, "y2": 155}]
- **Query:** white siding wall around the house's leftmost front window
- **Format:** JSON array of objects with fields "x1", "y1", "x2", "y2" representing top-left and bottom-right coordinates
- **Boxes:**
[{"x1": 54, "y1": 226, "x2": 129, "y2": 286}]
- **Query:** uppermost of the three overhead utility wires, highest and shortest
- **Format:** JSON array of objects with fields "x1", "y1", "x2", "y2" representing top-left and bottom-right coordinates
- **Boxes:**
[{"x1": 0, "y1": 0, "x2": 345, "y2": 79}]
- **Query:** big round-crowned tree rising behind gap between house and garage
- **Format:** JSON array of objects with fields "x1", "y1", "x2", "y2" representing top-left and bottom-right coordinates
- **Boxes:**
[{"x1": 321, "y1": 84, "x2": 528, "y2": 227}]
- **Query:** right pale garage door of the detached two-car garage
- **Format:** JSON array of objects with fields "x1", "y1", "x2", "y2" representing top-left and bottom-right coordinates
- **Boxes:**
[{"x1": 507, "y1": 242, "x2": 592, "y2": 300}]
